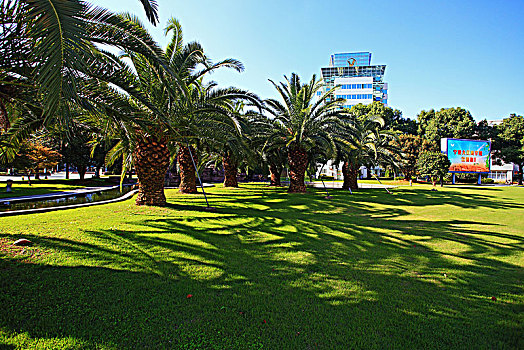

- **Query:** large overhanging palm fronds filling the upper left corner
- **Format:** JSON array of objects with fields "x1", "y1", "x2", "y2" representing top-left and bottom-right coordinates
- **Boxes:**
[{"x1": 0, "y1": 0, "x2": 164, "y2": 162}]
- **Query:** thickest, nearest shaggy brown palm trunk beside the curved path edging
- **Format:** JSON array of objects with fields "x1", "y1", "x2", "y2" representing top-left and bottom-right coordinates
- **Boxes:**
[{"x1": 133, "y1": 136, "x2": 169, "y2": 206}]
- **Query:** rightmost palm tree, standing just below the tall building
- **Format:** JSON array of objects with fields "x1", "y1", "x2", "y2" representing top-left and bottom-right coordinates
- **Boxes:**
[{"x1": 338, "y1": 115, "x2": 398, "y2": 190}]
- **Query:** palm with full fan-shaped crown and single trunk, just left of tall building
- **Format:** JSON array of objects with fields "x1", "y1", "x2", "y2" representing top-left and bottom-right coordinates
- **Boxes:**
[{"x1": 266, "y1": 73, "x2": 344, "y2": 193}]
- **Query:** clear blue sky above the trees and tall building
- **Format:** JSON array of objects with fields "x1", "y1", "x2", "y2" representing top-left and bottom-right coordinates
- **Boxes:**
[{"x1": 90, "y1": 0, "x2": 524, "y2": 120}]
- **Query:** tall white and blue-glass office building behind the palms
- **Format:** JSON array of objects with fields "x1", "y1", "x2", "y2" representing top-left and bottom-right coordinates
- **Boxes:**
[{"x1": 317, "y1": 52, "x2": 388, "y2": 108}]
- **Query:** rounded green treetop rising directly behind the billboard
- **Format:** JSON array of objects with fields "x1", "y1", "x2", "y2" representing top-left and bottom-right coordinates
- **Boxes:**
[{"x1": 417, "y1": 107, "x2": 476, "y2": 150}]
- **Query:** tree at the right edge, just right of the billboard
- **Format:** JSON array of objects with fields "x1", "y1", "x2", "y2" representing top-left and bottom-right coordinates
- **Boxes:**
[{"x1": 494, "y1": 114, "x2": 524, "y2": 185}]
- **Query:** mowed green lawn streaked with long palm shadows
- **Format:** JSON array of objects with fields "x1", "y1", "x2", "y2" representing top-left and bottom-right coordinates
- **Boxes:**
[{"x1": 0, "y1": 184, "x2": 524, "y2": 349}]
